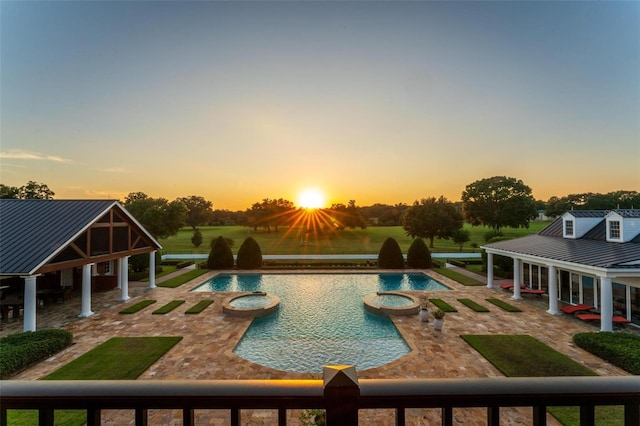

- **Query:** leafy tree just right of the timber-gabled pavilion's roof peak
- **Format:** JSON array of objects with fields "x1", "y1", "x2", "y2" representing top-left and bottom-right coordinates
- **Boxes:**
[{"x1": 123, "y1": 192, "x2": 188, "y2": 238}]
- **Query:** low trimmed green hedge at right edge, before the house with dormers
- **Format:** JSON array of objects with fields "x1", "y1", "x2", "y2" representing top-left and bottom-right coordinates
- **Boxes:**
[{"x1": 573, "y1": 332, "x2": 640, "y2": 375}]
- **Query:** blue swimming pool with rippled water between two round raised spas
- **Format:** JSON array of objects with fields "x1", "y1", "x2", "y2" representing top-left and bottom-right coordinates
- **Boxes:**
[{"x1": 193, "y1": 273, "x2": 448, "y2": 373}]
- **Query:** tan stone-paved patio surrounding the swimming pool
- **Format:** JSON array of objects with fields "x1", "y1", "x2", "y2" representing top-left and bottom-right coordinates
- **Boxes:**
[{"x1": 2, "y1": 271, "x2": 628, "y2": 426}]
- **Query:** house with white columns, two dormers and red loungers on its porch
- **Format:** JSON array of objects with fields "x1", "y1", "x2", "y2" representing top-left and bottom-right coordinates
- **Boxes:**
[{"x1": 482, "y1": 209, "x2": 640, "y2": 331}]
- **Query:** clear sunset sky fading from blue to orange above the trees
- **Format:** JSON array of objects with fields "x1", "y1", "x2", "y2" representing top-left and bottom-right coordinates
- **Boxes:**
[{"x1": 0, "y1": 1, "x2": 640, "y2": 210}]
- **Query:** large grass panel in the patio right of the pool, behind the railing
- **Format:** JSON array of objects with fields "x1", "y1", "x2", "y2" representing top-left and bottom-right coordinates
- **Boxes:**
[{"x1": 460, "y1": 335, "x2": 624, "y2": 426}]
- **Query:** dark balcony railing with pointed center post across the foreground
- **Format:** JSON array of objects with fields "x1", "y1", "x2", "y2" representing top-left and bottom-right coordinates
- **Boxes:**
[{"x1": 0, "y1": 366, "x2": 640, "y2": 426}]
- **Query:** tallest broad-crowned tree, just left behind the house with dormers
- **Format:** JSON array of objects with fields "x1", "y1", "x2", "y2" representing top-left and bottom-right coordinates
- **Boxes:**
[{"x1": 462, "y1": 176, "x2": 536, "y2": 230}]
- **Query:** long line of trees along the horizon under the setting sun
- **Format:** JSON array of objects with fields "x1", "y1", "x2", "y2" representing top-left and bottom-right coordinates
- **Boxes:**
[{"x1": 0, "y1": 176, "x2": 640, "y2": 247}]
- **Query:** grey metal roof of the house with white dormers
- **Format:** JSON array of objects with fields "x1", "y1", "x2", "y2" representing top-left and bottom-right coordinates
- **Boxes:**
[{"x1": 483, "y1": 212, "x2": 640, "y2": 269}]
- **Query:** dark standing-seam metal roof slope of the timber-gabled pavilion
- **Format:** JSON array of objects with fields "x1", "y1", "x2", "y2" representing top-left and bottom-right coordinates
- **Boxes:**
[{"x1": 0, "y1": 200, "x2": 116, "y2": 275}]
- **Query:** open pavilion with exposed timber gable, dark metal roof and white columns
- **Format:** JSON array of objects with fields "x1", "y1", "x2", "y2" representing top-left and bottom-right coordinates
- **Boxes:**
[{"x1": 0, "y1": 200, "x2": 162, "y2": 331}]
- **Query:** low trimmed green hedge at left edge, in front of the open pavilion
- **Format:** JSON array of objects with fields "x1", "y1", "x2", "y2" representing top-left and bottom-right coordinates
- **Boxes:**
[{"x1": 0, "y1": 329, "x2": 73, "y2": 379}]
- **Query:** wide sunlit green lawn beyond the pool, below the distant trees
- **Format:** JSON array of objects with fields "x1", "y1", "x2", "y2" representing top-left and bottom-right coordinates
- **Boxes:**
[{"x1": 160, "y1": 222, "x2": 549, "y2": 254}]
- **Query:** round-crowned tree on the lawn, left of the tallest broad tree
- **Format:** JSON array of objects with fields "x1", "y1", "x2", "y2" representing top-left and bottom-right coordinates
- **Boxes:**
[{"x1": 402, "y1": 196, "x2": 462, "y2": 247}]
